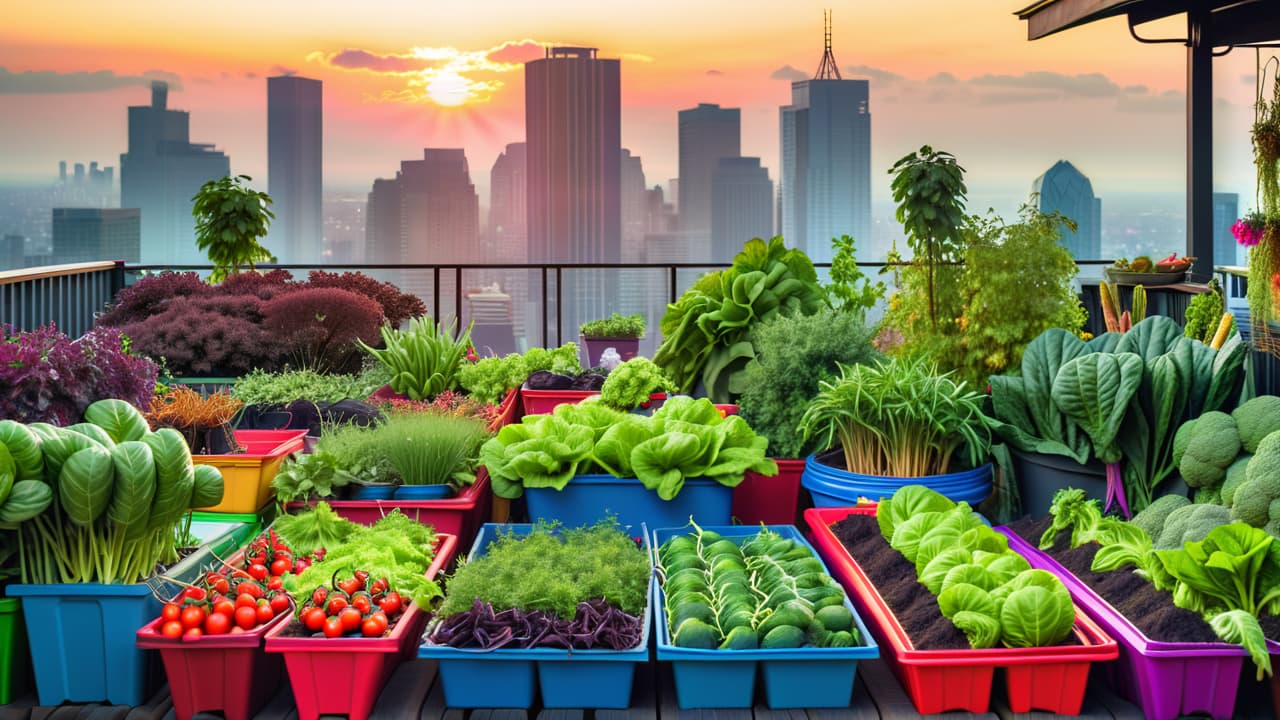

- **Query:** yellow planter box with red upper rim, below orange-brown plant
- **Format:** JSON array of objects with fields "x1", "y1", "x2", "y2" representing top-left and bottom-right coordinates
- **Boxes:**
[{"x1": 192, "y1": 429, "x2": 307, "y2": 512}]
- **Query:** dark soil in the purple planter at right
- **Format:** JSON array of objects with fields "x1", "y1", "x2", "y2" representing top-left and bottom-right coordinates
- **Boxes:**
[{"x1": 1009, "y1": 518, "x2": 1223, "y2": 642}]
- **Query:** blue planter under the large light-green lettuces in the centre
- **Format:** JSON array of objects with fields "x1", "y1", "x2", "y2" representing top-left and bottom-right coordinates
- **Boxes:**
[{"x1": 525, "y1": 475, "x2": 733, "y2": 532}]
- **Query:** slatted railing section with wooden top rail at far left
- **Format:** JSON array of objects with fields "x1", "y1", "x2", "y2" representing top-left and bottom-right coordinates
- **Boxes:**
[{"x1": 0, "y1": 260, "x2": 125, "y2": 337}]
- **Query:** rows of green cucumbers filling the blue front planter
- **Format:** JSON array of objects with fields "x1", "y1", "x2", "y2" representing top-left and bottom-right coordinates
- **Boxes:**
[{"x1": 658, "y1": 525, "x2": 861, "y2": 651}]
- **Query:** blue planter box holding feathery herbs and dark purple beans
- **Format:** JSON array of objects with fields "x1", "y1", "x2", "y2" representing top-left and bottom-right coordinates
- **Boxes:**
[{"x1": 417, "y1": 523, "x2": 654, "y2": 708}]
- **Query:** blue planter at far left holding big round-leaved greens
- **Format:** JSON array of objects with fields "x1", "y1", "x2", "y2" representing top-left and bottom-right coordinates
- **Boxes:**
[{"x1": 6, "y1": 525, "x2": 244, "y2": 706}]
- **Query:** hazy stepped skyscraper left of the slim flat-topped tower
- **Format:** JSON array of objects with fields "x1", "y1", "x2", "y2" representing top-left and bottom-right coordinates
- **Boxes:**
[{"x1": 120, "y1": 81, "x2": 232, "y2": 264}]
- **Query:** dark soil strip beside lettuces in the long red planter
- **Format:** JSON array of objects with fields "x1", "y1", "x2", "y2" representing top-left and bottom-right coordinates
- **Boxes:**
[{"x1": 831, "y1": 515, "x2": 969, "y2": 650}]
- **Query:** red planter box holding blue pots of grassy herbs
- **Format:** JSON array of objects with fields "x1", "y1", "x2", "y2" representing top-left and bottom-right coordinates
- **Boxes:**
[{"x1": 288, "y1": 465, "x2": 493, "y2": 542}]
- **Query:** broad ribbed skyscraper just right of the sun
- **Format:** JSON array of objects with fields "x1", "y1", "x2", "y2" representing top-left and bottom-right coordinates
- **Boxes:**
[{"x1": 525, "y1": 47, "x2": 622, "y2": 342}]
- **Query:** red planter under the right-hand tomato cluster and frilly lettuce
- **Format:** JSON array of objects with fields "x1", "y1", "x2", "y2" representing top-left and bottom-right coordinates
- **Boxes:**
[{"x1": 266, "y1": 533, "x2": 458, "y2": 720}]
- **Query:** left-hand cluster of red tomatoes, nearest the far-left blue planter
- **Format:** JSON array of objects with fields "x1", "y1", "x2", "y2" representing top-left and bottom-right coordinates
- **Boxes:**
[{"x1": 160, "y1": 573, "x2": 293, "y2": 638}]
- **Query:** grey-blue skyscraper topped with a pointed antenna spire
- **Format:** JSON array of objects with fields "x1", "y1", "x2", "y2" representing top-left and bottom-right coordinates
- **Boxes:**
[{"x1": 778, "y1": 10, "x2": 872, "y2": 263}]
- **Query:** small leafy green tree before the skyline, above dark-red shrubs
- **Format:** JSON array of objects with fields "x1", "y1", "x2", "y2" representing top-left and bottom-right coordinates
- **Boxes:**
[{"x1": 191, "y1": 176, "x2": 275, "y2": 283}]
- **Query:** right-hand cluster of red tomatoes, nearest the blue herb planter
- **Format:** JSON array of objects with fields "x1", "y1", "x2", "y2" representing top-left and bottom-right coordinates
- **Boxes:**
[{"x1": 298, "y1": 570, "x2": 406, "y2": 638}]
